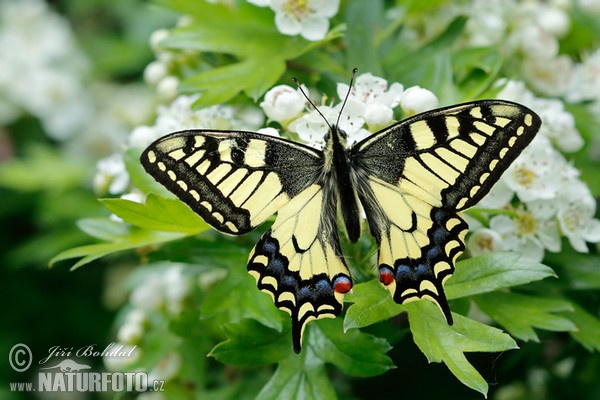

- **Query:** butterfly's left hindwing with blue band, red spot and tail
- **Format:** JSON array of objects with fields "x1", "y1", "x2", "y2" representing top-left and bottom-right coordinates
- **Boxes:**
[{"x1": 248, "y1": 184, "x2": 352, "y2": 353}]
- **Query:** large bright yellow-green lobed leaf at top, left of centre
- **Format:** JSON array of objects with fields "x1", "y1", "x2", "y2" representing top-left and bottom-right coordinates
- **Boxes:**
[{"x1": 159, "y1": 0, "x2": 318, "y2": 107}]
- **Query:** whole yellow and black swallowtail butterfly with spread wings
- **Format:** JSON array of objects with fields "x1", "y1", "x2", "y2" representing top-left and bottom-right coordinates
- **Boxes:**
[{"x1": 141, "y1": 100, "x2": 540, "y2": 352}]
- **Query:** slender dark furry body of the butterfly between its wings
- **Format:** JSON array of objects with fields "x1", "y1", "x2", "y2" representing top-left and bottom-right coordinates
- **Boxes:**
[{"x1": 323, "y1": 125, "x2": 360, "y2": 242}]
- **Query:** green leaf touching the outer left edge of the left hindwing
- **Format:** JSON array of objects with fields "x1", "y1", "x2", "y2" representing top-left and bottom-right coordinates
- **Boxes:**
[{"x1": 201, "y1": 264, "x2": 284, "y2": 332}]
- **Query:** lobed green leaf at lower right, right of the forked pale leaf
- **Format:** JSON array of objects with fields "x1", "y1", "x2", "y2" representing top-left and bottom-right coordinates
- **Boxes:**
[{"x1": 474, "y1": 292, "x2": 576, "y2": 342}]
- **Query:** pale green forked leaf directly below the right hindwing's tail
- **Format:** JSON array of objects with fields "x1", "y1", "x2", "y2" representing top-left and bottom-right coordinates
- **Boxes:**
[{"x1": 405, "y1": 300, "x2": 518, "y2": 395}]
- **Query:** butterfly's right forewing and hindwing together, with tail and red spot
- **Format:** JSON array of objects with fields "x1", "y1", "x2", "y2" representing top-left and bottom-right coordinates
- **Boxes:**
[{"x1": 351, "y1": 100, "x2": 540, "y2": 323}]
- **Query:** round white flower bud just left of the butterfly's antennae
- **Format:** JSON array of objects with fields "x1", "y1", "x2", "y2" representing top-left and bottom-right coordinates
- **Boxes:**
[{"x1": 260, "y1": 85, "x2": 306, "y2": 126}]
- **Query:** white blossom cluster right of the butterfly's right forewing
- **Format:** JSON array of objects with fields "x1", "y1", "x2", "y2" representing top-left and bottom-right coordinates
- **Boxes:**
[{"x1": 468, "y1": 81, "x2": 600, "y2": 261}]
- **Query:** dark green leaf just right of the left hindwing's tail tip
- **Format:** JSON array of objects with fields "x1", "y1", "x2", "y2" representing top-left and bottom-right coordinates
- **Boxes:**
[{"x1": 305, "y1": 318, "x2": 395, "y2": 377}]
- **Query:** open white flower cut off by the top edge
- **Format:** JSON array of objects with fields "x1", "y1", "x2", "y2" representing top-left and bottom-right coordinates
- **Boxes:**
[{"x1": 255, "y1": 0, "x2": 340, "y2": 41}]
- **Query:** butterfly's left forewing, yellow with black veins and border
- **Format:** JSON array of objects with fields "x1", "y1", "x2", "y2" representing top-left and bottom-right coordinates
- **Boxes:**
[{"x1": 141, "y1": 130, "x2": 322, "y2": 235}]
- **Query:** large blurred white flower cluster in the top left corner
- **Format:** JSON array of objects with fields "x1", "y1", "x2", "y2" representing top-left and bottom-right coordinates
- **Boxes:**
[{"x1": 0, "y1": 0, "x2": 92, "y2": 140}]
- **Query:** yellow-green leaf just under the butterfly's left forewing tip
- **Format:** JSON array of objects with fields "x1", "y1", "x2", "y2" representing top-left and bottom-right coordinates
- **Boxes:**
[{"x1": 100, "y1": 193, "x2": 209, "y2": 235}]
